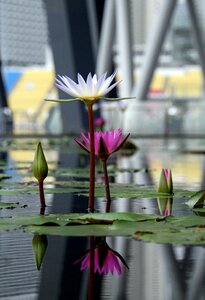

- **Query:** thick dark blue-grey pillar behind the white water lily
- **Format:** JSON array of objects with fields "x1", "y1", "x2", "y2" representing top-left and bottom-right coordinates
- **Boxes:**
[{"x1": 45, "y1": 0, "x2": 95, "y2": 133}]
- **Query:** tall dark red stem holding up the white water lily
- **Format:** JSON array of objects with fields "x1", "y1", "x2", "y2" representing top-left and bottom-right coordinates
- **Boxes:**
[{"x1": 87, "y1": 104, "x2": 95, "y2": 213}]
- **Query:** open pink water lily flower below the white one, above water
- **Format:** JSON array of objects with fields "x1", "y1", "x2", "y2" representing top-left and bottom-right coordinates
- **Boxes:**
[{"x1": 75, "y1": 129, "x2": 129, "y2": 159}]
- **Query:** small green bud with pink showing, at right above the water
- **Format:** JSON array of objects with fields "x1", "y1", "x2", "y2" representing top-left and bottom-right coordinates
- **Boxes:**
[{"x1": 158, "y1": 169, "x2": 173, "y2": 194}]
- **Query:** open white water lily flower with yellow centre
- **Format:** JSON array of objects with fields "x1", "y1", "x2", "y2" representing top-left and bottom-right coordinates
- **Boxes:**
[{"x1": 56, "y1": 72, "x2": 120, "y2": 102}]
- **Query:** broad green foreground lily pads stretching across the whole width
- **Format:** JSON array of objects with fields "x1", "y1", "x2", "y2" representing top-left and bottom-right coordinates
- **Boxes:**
[{"x1": 0, "y1": 213, "x2": 205, "y2": 245}]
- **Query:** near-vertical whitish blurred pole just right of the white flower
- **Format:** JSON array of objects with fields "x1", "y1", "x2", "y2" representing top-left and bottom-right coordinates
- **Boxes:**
[{"x1": 115, "y1": 0, "x2": 133, "y2": 97}]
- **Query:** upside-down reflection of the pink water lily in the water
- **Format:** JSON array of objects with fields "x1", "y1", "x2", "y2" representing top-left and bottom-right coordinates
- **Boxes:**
[{"x1": 76, "y1": 241, "x2": 128, "y2": 275}]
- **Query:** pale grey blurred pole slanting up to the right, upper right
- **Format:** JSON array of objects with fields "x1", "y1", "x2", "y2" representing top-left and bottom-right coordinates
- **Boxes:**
[{"x1": 133, "y1": 0, "x2": 177, "y2": 100}]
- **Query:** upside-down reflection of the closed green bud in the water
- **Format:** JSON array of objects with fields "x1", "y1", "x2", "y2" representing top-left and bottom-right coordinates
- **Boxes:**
[{"x1": 32, "y1": 234, "x2": 48, "y2": 270}]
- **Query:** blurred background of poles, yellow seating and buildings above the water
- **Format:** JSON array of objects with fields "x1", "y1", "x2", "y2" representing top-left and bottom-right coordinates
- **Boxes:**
[{"x1": 0, "y1": 0, "x2": 205, "y2": 136}]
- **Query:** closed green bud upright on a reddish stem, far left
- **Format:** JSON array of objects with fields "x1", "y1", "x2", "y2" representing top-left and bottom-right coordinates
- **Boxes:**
[{"x1": 33, "y1": 142, "x2": 48, "y2": 181}]
